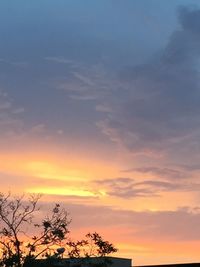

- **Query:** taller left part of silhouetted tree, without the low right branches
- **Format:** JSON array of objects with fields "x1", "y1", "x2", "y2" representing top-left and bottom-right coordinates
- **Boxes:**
[{"x1": 0, "y1": 193, "x2": 70, "y2": 267}]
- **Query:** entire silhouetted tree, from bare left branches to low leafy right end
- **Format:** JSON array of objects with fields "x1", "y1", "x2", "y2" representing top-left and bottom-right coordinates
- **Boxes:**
[{"x1": 0, "y1": 193, "x2": 117, "y2": 267}]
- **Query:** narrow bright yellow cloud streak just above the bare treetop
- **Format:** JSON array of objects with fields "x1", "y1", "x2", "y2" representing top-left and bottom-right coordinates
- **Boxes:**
[{"x1": 0, "y1": 173, "x2": 101, "y2": 201}]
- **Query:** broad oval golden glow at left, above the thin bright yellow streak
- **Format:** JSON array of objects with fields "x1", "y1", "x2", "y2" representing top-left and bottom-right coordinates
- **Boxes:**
[{"x1": 0, "y1": 151, "x2": 118, "y2": 181}]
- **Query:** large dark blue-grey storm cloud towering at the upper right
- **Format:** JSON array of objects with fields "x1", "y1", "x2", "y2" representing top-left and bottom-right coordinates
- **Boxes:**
[{"x1": 98, "y1": 8, "x2": 200, "y2": 155}]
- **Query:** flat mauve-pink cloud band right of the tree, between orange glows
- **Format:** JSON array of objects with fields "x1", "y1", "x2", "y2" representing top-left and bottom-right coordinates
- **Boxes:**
[{"x1": 41, "y1": 202, "x2": 200, "y2": 242}]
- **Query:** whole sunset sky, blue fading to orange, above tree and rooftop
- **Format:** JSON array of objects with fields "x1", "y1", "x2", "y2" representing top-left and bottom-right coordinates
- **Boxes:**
[{"x1": 0, "y1": 0, "x2": 200, "y2": 265}]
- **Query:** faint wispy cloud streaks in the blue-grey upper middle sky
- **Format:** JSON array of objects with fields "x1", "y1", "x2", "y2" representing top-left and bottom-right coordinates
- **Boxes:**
[{"x1": 53, "y1": 60, "x2": 119, "y2": 102}]
